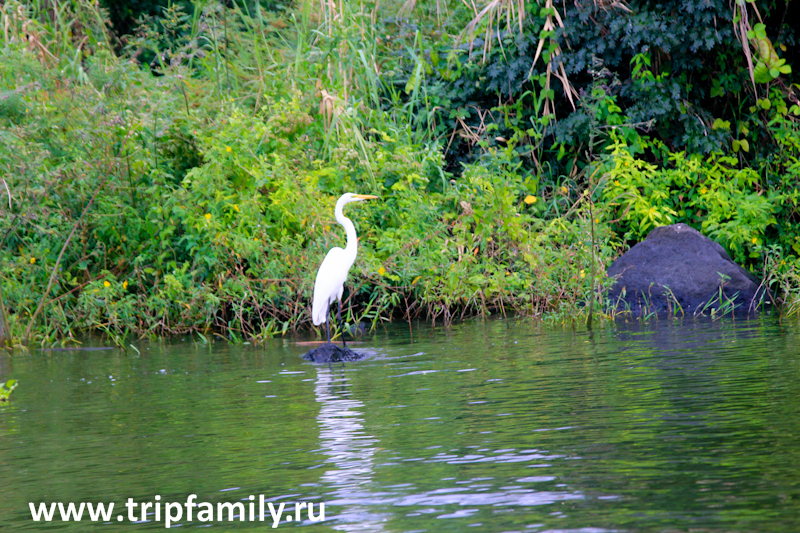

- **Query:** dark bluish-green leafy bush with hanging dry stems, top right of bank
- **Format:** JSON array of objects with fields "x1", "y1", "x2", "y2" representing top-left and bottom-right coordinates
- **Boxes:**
[{"x1": 387, "y1": 0, "x2": 797, "y2": 183}]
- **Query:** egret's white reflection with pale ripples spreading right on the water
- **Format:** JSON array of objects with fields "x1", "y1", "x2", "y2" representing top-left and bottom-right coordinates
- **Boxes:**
[{"x1": 315, "y1": 366, "x2": 588, "y2": 531}]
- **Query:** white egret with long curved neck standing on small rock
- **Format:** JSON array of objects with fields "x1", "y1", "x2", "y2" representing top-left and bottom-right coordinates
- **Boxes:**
[{"x1": 311, "y1": 192, "x2": 378, "y2": 348}]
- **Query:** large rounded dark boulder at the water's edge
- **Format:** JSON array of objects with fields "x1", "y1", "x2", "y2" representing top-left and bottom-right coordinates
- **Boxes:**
[{"x1": 608, "y1": 224, "x2": 768, "y2": 315}]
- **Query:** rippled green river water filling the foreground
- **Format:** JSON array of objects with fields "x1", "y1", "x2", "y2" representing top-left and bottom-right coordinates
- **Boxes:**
[{"x1": 0, "y1": 319, "x2": 800, "y2": 533}]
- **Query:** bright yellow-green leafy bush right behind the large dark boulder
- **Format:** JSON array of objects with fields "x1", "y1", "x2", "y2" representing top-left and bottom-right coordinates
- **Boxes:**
[{"x1": 601, "y1": 134, "x2": 784, "y2": 263}]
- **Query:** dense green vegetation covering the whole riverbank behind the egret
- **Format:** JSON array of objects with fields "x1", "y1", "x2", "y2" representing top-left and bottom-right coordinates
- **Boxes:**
[{"x1": 0, "y1": 0, "x2": 800, "y2": 344}]
